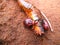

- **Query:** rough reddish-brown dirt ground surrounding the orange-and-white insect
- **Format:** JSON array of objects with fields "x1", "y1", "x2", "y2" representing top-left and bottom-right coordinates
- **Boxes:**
[{"x1": 0, "y1": 0, "x2": 60, "y2": 45}]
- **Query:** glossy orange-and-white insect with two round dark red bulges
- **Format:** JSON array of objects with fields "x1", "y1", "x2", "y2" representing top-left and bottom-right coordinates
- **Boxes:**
[{"x1": 18, "y1": 0, "x2": 53, "y2": 35}]
